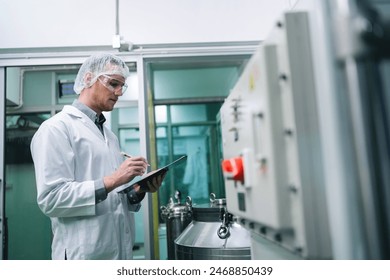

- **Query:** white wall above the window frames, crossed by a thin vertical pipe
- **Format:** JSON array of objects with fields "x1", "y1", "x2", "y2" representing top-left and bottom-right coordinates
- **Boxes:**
[{"x1": 0, "y1": 0, "x2": 295, "y2": 49}]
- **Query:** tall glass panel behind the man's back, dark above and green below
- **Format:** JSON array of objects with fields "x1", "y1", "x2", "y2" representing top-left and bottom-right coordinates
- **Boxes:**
[{"x1": 5, "y1": 113, "x2": 52, "y2": 260}]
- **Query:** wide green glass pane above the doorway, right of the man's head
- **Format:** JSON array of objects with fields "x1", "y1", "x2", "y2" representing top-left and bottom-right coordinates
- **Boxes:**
[{"x1": 153, "y1": 67, "x2": 239, "y2": 99}]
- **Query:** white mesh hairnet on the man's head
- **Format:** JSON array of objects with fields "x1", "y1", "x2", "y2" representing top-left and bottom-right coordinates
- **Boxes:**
[{"x1": 73, "y1": 54, "x2": 130, "y2": 94}]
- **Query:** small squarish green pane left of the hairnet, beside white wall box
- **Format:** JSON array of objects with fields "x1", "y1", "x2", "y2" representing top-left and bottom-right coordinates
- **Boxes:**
[{"x1": 23, "y1": 71, "x2": 53, "y2": 107}]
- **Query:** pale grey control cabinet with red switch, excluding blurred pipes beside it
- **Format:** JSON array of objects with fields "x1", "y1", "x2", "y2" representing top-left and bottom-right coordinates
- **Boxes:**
[{"x1": 221, "y1": 12, "x2": 330, "y2": 258}]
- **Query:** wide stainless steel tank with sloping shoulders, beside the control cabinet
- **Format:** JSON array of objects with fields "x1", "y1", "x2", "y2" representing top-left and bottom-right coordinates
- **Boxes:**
[{"x1": 175, "y1": 194, "x2": 251, "y2": 260}]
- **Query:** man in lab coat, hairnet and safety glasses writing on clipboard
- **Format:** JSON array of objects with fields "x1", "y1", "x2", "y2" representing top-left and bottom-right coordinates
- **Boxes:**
[{"x1": 31, "y1": 54, "x2": 165, "y2": 259}]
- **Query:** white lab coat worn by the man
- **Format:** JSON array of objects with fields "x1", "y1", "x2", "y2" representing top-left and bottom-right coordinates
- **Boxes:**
[{"x1": 31, "y1": 106, "x2": 136, "y2": 259}]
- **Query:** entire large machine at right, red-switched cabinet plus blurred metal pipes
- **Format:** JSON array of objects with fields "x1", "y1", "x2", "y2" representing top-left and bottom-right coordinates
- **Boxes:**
[{"x1": 220, "y1": 0, "x2": 390, "y2": 259}]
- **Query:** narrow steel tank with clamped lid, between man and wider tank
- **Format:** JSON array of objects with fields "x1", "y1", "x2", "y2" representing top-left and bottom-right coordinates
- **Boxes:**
[{"x1": 160, "y1": 191, "x2": 191, "y2": 260}]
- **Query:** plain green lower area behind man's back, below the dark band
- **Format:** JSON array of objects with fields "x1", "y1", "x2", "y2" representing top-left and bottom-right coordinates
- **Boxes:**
[{"x1": 5, "y1": 164, "x2": 52, "y2": 260}]
